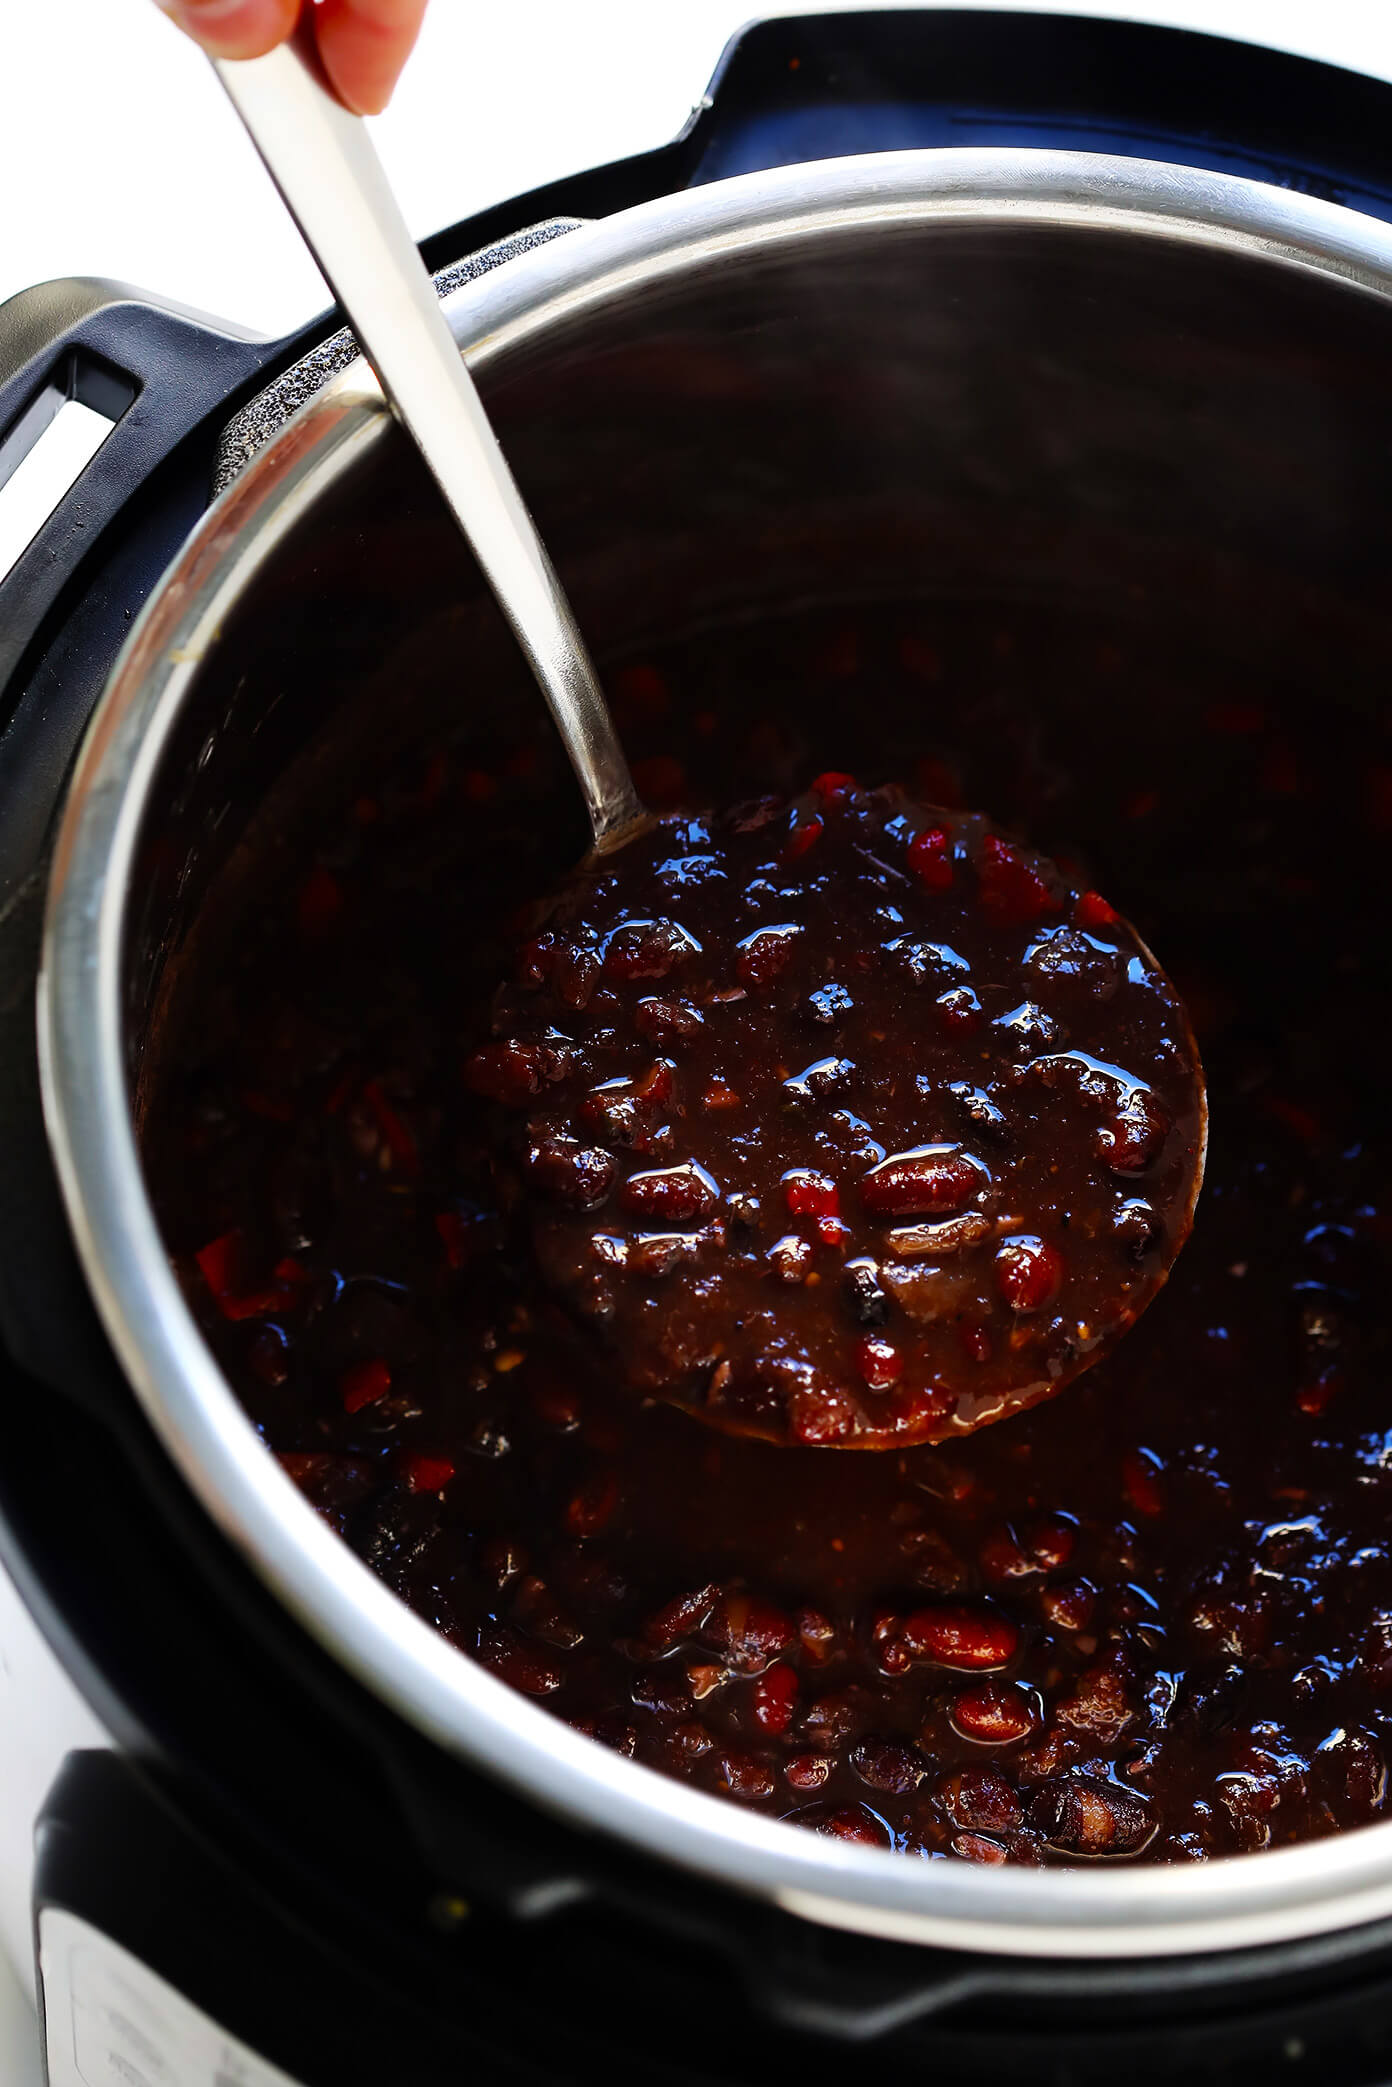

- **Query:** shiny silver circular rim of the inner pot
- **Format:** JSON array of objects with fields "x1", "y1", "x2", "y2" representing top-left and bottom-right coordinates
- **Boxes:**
[{"x1": 38, "y1": 148, "x2": 1392, "y2": 1958}]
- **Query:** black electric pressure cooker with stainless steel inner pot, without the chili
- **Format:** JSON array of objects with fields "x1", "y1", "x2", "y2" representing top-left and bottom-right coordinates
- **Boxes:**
[{"x1": 0, "y1": 10, "x2": 1392, "y2": 2087}]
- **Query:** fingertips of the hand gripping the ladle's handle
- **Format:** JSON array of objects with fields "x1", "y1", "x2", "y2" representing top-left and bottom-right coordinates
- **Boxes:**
[{"x1": 159, "y1": 0, "x2": 426, "y2": 117}]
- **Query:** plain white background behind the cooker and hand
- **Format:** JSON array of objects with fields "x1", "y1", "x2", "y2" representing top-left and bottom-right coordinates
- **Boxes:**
[{"x1": 0, "y1": 0, "x2": 1392, "y2": 2087}]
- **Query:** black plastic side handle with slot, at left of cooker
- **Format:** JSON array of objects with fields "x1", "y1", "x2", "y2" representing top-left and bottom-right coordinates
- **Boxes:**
[{"x1": 0, "y1": 278, "x2": 284, "y2": 705}]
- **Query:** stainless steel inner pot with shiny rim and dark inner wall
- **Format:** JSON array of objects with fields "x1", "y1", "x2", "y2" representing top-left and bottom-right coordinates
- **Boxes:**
[{"x1": 40, "y1": 150, "x2": 1392, "y2": 1958}]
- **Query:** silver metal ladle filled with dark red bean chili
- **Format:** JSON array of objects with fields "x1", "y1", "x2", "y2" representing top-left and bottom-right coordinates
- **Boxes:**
[{"x1": 217, "y1": 40, "x2": 1204, "y2": 1448}]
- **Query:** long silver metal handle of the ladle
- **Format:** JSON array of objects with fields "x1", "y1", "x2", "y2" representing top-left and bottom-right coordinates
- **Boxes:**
[{"x1": 213, "y1": 35, "x2": 643, "y2": 849}]
